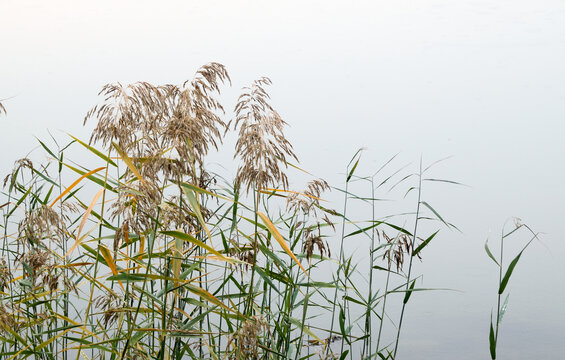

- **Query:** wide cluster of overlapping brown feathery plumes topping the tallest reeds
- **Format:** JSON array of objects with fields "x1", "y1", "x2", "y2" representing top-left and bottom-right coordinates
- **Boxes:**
[{"x1": 84, "y1": 63, "x2": 230, "y2": 180}]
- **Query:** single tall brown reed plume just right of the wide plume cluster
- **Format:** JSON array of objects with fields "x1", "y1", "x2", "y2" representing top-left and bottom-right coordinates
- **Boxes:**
[{"x1": 234, "y1": 78, "x2": 298, "y2": 192}]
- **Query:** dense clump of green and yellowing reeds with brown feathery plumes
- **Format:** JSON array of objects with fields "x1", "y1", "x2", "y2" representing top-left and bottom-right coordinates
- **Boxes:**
[{"x1": 0, "y1": 63, "x2": 536, "y2": 360}]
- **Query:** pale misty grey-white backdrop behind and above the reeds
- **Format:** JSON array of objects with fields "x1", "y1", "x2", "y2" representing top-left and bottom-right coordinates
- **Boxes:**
[{"x1": 0, "y1": 0, "x2": 565, "y2": 359}]
